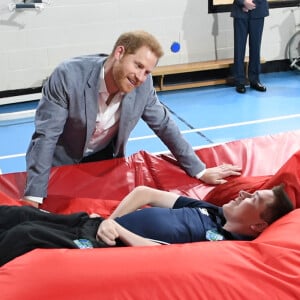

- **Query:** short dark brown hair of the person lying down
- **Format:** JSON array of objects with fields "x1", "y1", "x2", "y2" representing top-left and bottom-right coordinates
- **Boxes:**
[{"x1": 261, "y1": 184, "x2": 294, "y2": 225}]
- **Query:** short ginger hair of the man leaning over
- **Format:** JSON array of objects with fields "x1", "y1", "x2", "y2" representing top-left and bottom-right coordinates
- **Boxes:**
[{"x1": 112, "y1": 31, "x2": 164, "y2": 59}]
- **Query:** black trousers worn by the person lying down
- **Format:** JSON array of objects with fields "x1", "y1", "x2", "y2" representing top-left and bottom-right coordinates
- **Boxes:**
[{"x1": 0, "y1": 205, "x2": 107, "y2": 265}]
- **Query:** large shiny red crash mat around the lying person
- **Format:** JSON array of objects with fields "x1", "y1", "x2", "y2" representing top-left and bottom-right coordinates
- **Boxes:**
[{"x1": 0, "y1": 131, "x2": 300, "y2": 300}]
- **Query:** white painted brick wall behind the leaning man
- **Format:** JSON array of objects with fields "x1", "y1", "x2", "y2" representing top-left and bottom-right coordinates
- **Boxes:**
[{"x1": 0, "y1": 0, "x2": 300, "y2": 91}]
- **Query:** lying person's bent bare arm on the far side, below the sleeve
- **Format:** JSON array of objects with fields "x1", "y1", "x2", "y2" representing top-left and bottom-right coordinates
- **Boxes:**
[{"x1": 109, "y1": 186, "x2": 179, "y2": 219}]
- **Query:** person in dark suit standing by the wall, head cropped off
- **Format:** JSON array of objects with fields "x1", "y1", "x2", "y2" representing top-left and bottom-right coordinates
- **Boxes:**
[{"x1": 231, "y1": 0, "x2": 269, "y2": 94}]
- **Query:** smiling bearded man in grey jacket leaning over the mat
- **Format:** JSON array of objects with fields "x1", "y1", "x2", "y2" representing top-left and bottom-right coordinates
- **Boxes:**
[{"x1": 24, "y1": 31, "x2": 241, "y2": 207}]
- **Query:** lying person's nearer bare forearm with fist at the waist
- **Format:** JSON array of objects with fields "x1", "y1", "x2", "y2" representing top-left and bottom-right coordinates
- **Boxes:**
[{"x1": 97, "y1": 219, "x2": 161, "y2": 246}]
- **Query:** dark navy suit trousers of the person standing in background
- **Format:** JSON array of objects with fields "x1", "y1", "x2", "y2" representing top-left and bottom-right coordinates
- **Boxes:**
[{"x1": 233, "y1": 18, "x2": 264, "y2": 84}]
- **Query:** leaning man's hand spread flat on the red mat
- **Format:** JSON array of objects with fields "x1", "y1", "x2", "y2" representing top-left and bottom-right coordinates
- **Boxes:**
[{"x1": 199, "y1": 164, "x2": 241, "y2": 184}]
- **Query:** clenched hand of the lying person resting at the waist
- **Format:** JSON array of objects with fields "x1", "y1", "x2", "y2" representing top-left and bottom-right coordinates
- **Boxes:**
[{"x1": 96, "y1": 219, "x2": 119, "y2": 246}]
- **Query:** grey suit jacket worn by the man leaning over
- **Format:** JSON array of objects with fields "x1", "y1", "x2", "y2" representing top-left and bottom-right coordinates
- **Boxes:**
[{"x1": 25, "y1": 55, "x2": 205, "y2": 197}]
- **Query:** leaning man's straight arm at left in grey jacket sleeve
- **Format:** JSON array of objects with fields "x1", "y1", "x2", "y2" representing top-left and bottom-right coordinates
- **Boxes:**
[{"x1": 24, "y1": 68, "x2": 68, "y2": 203}]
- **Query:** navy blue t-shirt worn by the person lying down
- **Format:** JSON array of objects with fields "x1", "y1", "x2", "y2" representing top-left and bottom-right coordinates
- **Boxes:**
[{"x1": 115, "y1": 196, "x2": 250, "y2": 244}]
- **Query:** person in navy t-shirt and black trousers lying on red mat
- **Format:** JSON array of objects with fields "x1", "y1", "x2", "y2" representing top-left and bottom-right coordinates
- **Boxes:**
[{"x1": 0, "y1": 185, "x2": 293, "y2": 265}]
